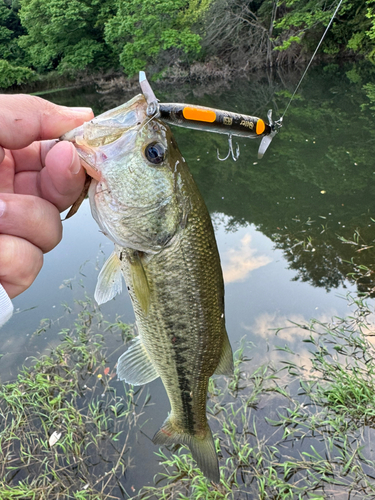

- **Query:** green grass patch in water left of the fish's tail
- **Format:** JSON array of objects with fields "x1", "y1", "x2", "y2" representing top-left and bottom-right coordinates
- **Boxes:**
[{"x1": 0, "y1": 301, "x2": 148, "y2": 500}]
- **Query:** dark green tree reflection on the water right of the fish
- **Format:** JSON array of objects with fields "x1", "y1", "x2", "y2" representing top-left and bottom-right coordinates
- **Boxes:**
[{"x1": 166, "y1": 64, "x2": 375, "y2": 290}]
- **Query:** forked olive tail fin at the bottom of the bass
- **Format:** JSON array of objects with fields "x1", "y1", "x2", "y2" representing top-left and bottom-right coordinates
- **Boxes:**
[{"x1": 152, "y1": 417, "x2": 220, "y2": 483}]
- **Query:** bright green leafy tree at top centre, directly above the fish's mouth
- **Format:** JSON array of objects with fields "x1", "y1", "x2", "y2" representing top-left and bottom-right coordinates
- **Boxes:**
[{"x1": 105, "y1": 0, "x2": 204, "y2": 75}]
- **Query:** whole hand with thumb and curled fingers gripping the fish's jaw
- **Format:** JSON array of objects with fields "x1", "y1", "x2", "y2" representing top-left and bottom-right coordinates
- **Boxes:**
[{"x1": 0, "y1": 94, "x2": 93, "y2": 298}]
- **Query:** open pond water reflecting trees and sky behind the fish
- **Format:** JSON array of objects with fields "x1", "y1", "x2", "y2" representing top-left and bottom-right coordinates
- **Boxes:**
[{"x1": 0, "y1": 60, "x2": 375, "y2": 489}]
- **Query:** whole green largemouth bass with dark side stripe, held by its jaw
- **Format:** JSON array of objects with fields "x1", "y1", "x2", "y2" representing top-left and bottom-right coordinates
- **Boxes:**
[{"x1": 64, "y1": 94, "x2": 233, "y2": 482}]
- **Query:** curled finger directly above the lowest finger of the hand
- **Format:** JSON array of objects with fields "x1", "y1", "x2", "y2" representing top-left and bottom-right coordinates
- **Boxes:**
[{"x1": 0, "y1": 193, "x2": 62, "y2": 253}]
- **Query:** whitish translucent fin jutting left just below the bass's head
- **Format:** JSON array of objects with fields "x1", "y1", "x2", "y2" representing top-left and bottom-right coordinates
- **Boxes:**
[{"x1": 94, "y1": 252, "x2": 122, "y2": 304}]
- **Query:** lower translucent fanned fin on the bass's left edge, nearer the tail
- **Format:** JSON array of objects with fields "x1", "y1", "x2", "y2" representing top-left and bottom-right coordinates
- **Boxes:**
[{"x1": 117, "y1": 337, "x2": 159, "y2": 385}]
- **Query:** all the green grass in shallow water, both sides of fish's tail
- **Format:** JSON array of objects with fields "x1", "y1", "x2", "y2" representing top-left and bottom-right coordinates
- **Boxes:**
[{"x1": 0, "y1": 297, "x2": 375, "y2": 500}]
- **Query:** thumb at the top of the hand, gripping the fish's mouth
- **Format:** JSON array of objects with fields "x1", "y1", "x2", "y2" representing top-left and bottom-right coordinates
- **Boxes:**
[{"x1": 0, "y1": 94, "x2": 93, "y2": 149}]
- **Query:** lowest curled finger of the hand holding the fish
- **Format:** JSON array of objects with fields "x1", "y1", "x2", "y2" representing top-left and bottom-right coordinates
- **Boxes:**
[{"x1": 0, "y1": 234, "x2": 43, "y2": 299}]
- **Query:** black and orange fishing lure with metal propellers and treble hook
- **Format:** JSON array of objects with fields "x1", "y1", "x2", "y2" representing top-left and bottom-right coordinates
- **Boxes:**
[{"x1": 139, "y1": 71, "x2": 280, "y2": 160}]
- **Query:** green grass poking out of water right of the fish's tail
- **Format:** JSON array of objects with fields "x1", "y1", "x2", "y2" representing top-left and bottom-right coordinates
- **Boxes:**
[{"x1": 134, "y1": 299, "x2": 375, "y2": 500}]
